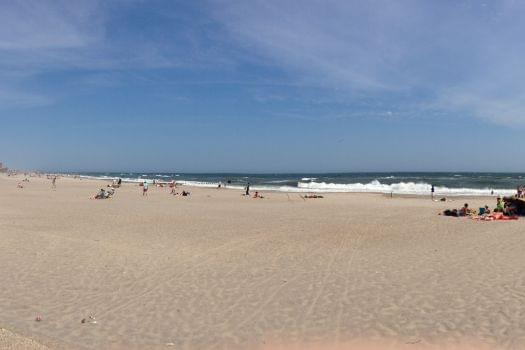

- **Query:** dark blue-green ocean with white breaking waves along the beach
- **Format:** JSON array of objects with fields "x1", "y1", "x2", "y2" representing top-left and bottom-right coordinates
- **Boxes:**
[{"x1": 67, "y1": 172, "x2": 525, "y2": 196}]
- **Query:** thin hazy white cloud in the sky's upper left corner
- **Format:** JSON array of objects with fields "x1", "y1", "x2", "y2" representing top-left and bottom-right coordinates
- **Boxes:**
[{"x1": 0, "y1": 0, "x2": 188, "y2": 108}]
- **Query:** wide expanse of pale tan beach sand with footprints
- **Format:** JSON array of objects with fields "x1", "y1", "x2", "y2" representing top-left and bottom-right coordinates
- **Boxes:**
[{"x1": 0, "y1": 175, "x2": 525, "y2": 349}]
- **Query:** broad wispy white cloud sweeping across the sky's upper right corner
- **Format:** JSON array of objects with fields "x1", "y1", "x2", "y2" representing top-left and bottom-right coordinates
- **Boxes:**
[{"x1": 212, "y1": 0, "x2": 525, "y2": 125}]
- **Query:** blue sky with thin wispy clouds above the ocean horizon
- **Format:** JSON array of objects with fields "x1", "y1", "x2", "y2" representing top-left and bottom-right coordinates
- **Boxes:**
[{"x1": 0, "y1": 0, "x2": 525, "y2": 173}]
